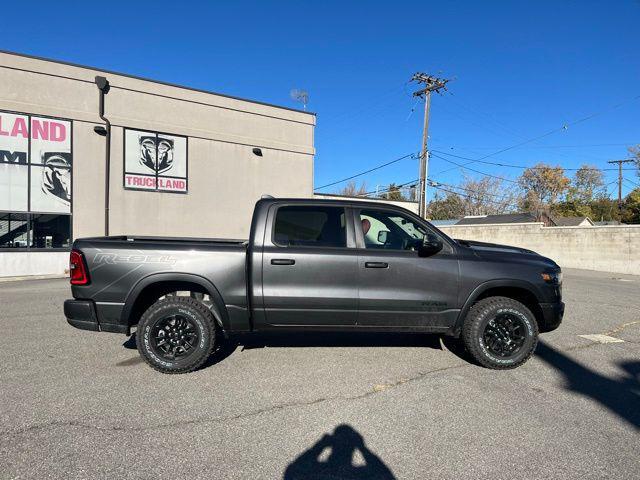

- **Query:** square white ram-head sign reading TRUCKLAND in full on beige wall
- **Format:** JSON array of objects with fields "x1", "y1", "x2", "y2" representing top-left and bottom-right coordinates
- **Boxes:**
[{"x1": 124, "y1": 129, "x2": 187, "y2": 193}]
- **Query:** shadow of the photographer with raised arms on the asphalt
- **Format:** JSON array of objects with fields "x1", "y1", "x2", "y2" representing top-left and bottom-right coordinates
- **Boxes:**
[{"x1": 282, "y1": 424, "x2": 396, "y2": 480}]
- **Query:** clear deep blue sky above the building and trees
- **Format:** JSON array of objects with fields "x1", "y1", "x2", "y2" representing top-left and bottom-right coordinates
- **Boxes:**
[{"x1": 0, "y1": 0, "x2": 640, "y2": 196}]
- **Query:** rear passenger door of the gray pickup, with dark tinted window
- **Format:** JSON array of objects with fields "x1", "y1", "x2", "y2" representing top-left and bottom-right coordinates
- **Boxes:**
[{"x1": 262, "y1": 204, "x2": 358, "y2": 327}]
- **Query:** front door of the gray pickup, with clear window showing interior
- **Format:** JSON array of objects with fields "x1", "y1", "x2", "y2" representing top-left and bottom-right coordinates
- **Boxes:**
[{"x1": 354, "y1": 208, "x2": 459, "y2": 329}]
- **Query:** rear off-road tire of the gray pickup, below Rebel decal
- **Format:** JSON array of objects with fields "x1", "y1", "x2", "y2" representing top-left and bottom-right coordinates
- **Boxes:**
[{"x1": 136, "y1": 297, "x2": 216, "y2": 373}]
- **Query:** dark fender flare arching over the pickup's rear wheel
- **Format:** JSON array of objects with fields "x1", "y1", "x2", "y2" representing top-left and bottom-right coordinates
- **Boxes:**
[{"x1": 120, "y1": 272, "x2": 230, "y2": 331}]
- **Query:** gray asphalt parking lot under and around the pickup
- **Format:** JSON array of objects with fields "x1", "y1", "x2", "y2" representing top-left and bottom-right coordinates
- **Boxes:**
[{"x1": 0, "y1": 270, "x2": 640, "y2": 480}]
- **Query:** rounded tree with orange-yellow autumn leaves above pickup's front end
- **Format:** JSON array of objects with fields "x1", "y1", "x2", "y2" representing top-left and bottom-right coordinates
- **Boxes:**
[{"x1": 518, "y1": 163, "x2": 570, "y2": 215}]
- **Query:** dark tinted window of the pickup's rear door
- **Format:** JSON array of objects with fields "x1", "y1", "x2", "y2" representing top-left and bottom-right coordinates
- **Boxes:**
[{"x1": 273, "y1": 206, "x2": 347, "y2": 247}]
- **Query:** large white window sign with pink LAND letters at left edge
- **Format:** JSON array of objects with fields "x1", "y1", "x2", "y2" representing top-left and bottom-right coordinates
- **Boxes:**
[{"x1": 0, "y1": 111, "x2": 72, "y2": 213}]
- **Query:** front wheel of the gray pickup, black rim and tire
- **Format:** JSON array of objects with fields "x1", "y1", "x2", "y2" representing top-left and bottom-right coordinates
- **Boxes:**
[{"x1": 462, "y1": 297, "x2": 538, "y2": 370}]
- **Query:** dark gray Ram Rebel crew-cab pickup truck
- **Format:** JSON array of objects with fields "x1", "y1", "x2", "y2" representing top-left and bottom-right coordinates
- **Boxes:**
[{"x1": 64, "y1": 198, "x2": 564, "y2": 373}]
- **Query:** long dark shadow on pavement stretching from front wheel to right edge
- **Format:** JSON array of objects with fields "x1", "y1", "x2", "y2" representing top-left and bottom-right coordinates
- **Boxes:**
[{"x1": 536, "y1": 341, "x2": 640, "y2": 429}]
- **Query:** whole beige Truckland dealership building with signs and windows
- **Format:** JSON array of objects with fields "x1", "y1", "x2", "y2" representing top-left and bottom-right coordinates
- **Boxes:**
[{"x1": 0, "y1": 52, "x2": 315, "y2": 276}]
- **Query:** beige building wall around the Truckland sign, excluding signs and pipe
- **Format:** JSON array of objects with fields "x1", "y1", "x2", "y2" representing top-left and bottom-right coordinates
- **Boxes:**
[{"x1": 0, "y1": 53, "x2": 315, "y2": 242}]
